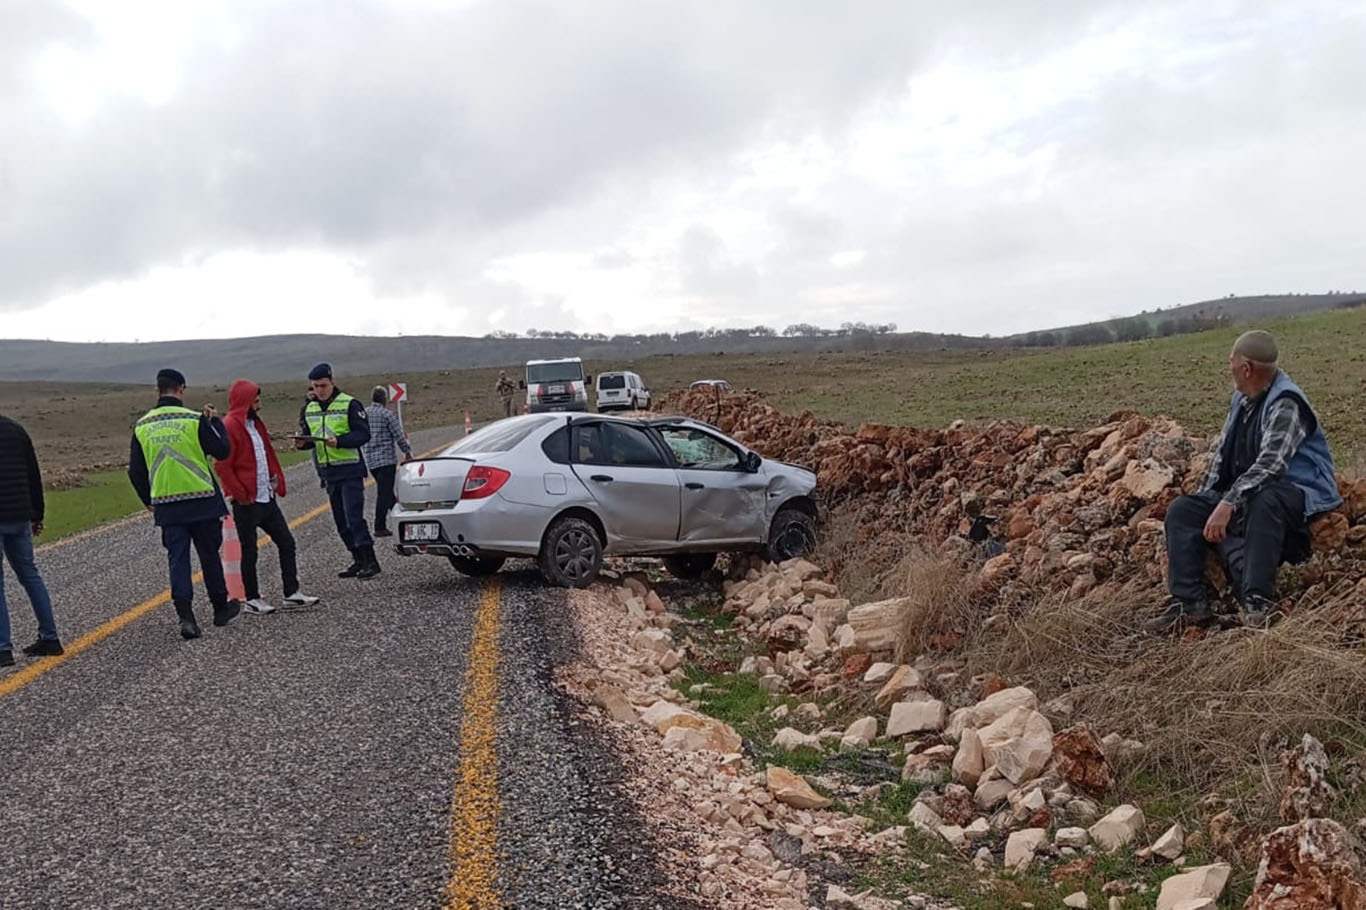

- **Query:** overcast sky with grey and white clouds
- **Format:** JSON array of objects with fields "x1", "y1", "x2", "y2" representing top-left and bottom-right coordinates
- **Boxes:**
[{"x1": 0, "y1": 0, "x2": 1366, "y2": 340}]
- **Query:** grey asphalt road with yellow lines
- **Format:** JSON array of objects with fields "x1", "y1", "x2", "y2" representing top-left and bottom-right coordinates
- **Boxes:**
[{"x1": 0, "y1": 430, "x2": 687, "y2": 910}]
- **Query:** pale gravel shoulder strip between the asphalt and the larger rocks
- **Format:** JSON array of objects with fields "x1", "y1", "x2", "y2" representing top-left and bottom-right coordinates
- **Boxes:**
[{"x1": 559, "y1": 577, "x2": 926, "y2": 910}]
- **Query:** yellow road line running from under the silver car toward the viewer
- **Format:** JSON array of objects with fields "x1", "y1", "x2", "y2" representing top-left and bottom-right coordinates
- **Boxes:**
[{"x1": 445, "y1": 577, "x2": 503, "y2": 910}]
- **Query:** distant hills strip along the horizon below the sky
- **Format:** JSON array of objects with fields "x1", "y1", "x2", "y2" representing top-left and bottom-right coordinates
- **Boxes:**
[{"x1": 0, "y1": 286, "x2": 1366, "y2": 384}]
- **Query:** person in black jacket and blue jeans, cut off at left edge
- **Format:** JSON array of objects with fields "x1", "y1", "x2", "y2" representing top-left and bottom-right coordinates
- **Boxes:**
[{"x1": 0, "y1": 417, "x2": 61, "y2": 667}]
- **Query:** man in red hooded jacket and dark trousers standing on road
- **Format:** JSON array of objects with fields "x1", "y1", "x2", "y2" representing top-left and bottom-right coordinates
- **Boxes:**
[{"x1": 213, "y1": 380, "x2": 318, "y2": 615}]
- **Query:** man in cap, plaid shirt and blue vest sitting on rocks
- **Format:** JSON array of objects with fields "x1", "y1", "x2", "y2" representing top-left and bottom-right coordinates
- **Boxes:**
[{"x1": 1143, "y1": 332, "x2": 1343, "y2": 631}]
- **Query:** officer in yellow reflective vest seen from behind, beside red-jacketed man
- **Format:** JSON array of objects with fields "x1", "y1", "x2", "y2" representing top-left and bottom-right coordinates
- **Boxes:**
[{"x1": 128, "y1": 369, "x2": 242, "y2": 639}]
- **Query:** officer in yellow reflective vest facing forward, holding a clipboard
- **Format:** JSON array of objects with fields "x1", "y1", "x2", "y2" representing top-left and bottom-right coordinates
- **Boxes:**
[{"x1": 298, "y1": 363, "x2": 380, "y2": 578}]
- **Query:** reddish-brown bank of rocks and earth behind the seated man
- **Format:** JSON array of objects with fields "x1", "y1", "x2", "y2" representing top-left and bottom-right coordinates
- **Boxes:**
[{"x1": 664, "y1": 382, "x2": 1366, "y2": 597}]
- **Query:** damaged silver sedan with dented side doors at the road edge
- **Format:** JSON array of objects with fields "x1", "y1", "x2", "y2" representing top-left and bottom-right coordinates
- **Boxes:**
[{"x1": 391, "y1": 414, "x2": 817, "y2": 588}]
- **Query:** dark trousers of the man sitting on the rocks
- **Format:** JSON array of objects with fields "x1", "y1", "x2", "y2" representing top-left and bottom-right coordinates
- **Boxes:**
[{"x1": 1167, "y1": 481, "x2": 1309, "y2": 603}]
